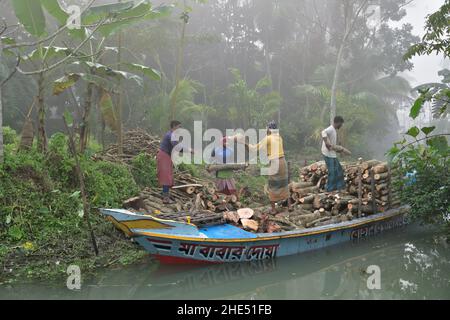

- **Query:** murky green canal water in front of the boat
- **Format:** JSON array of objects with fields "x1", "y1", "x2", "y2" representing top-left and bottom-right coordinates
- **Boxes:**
[{"x1": 0, "y1": 226, "x2": 450, "y2": 300}]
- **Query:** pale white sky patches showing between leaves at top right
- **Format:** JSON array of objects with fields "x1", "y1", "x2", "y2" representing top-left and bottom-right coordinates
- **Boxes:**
[{"x1": 402, "y1": 0, "x2": 450, "y2": 86}]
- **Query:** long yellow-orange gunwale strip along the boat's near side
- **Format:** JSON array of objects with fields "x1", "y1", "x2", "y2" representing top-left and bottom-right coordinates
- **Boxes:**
[{"x1": 133, "y1": 206, "x2": 408, "y2": 243}]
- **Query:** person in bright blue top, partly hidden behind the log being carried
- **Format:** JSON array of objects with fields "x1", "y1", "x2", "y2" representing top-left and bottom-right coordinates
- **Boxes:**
[{"x1": 211, "y1": 137, "x2": 237, "y2": 195}]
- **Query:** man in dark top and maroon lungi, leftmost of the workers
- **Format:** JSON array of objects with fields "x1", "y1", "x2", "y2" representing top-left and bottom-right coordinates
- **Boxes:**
[{"x1": 156, "y1": 120, "x2": 181, "y2": 204}]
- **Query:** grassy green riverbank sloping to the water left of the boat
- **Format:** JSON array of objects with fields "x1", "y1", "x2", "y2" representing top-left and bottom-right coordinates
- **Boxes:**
[{"x1": 0, "y1": 130, "x2": 266, "y2": 284}]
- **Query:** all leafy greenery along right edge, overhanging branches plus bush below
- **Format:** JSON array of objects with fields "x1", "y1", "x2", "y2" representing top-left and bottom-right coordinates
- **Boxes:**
[{"x1": 389, "y1": 0, "x2": 450, "y2": 233}]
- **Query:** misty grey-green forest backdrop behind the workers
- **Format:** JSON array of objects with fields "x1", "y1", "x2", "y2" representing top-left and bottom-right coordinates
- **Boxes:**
[{"x1": 0, "y1": 0, "x2": 449, "y2": 159}]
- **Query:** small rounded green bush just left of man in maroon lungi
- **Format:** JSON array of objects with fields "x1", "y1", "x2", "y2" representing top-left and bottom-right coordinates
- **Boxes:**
[{"x1": 131, "y1": 153, "x2": 158, "y2": 188}]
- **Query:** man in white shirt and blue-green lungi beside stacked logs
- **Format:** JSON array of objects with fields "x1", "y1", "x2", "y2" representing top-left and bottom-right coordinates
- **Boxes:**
[{"x1": 322, "y1": 116, "x2": 350, "y2": 192}]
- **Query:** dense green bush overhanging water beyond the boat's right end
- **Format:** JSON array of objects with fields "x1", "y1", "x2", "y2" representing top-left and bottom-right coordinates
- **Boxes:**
[{"x1": 388, "y1": 97, "x2": 450, "y2": 231}]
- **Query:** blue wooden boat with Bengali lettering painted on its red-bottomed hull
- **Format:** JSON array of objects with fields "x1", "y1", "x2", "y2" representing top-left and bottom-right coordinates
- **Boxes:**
[{"x1": 101, "y1": 206, "x2": 409, "y2": 264}]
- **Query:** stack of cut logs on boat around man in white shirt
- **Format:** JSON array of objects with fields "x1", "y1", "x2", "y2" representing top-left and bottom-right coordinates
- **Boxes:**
[{"x1": 290, "y1": 160, "x2": 400, "y2": 221}]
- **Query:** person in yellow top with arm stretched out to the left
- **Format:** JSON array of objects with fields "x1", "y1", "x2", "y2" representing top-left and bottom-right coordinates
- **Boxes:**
[{"x1": 238, "y1": 121, "x2": 292, "y2": 214}]
